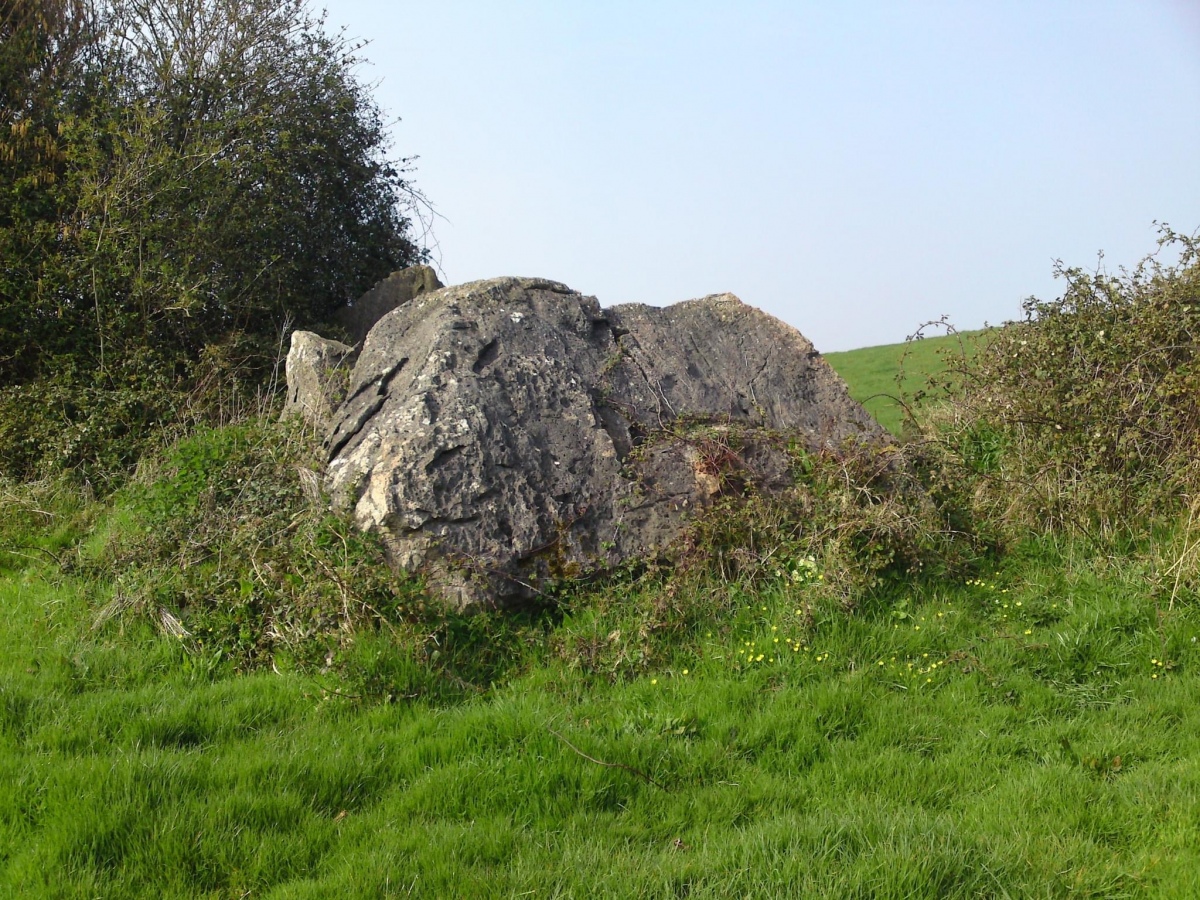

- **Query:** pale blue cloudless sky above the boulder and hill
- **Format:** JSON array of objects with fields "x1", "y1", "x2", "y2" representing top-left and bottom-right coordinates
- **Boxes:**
[{"x1": 329, "y1": 0, "x2": 1200, "y2": 352}]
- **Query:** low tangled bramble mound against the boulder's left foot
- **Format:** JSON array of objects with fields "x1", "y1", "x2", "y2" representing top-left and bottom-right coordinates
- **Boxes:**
[{"x1": 76, "y1": 419, "x2": 409, "y2": 667}]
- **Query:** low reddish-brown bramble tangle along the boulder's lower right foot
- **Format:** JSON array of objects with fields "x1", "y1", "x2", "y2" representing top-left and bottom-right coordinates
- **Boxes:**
[{"x1": 554, "y1": 422, "x2": 989, "y2": 678}]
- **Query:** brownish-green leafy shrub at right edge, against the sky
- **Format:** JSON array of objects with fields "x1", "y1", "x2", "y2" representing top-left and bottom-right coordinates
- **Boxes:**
[{"x1": 923, "y1": 227, "x2": 1200, "y2": 533}]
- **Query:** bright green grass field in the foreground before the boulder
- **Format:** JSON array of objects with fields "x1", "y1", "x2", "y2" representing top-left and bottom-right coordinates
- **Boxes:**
[{"x1": 0, "y1": 342, "x2": 1200, "y2": 898}]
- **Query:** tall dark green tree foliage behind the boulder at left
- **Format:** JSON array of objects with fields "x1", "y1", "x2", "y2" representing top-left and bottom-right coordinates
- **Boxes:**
[{"x1": 0, "y1": 0, "x2": 421, "y2": 487}]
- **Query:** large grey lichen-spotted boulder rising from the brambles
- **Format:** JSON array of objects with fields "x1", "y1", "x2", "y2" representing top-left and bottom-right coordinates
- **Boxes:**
[{"x1": 325, "y1": 278, "x2": 887, "y2": 607}]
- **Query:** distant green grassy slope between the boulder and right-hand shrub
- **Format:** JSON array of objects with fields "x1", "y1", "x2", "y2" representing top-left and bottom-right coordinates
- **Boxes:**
[{"x1": 824, "y1": 331, "x2": 983, "y2": 434}]
